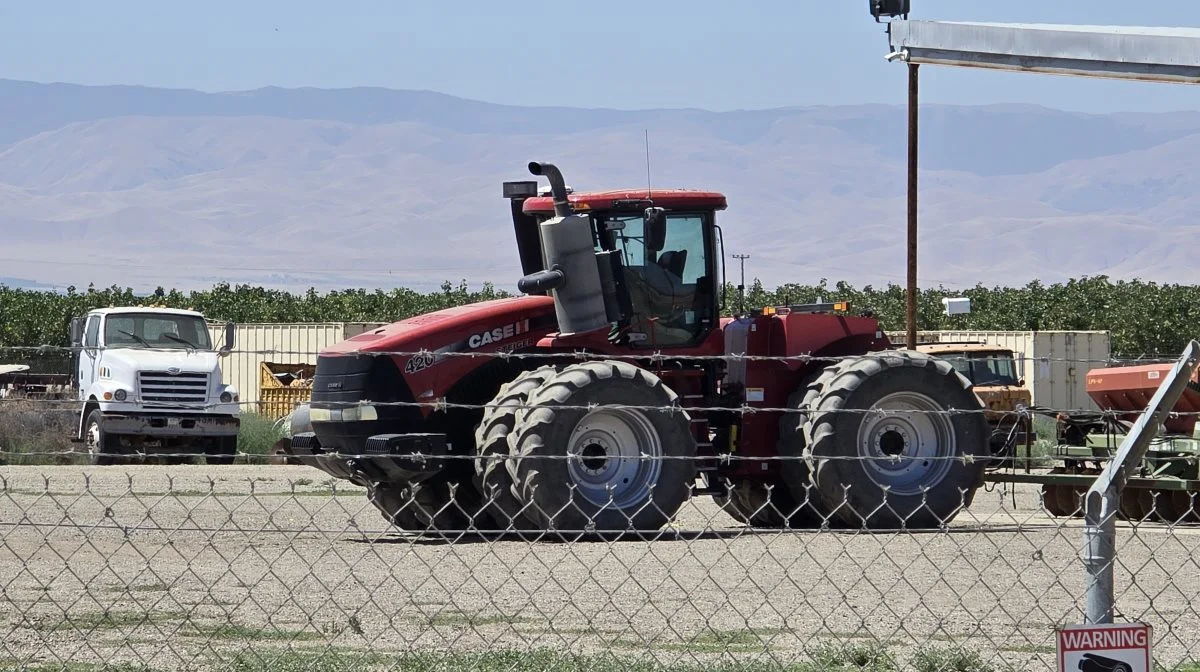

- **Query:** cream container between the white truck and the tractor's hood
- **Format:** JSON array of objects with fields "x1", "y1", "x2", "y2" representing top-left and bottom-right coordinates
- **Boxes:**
[{"x1": 210, "y1": 322, "x2": 383, "y2": 416}]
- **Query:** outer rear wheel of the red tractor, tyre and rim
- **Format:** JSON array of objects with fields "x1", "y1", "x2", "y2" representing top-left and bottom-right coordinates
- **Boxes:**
[{"x1": 803, "y1": 350, "x2": 991, "y2": 528}]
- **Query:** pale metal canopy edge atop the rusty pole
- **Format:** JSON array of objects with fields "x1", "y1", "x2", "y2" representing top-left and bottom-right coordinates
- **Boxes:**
[{"x1": 888, "y1": 19, "x2": 1200, "y2": 84}]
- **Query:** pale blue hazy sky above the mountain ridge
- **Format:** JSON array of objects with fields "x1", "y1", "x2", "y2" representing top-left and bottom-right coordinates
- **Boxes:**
[{"x1": 0, "y1": 0, "x2": 1200, "y2": 112}]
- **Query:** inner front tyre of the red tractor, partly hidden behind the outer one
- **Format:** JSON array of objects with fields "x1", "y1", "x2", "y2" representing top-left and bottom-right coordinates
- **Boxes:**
[{"x1": 475, "y1": 366, "x2": 558, "y2": 530}]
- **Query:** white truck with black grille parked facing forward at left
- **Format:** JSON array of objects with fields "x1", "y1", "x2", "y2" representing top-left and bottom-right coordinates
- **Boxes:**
[{"x1": 71, "y1": 307, "x2": 240, "y2": 464}]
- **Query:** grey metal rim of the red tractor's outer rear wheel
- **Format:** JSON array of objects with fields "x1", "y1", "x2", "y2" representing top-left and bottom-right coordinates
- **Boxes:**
[{"x1": 858, "y1": 392, "x2": 958, "y2": 496}]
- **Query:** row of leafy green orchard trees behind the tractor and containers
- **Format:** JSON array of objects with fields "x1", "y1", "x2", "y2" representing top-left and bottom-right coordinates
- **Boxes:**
[{"x1": 0, "y1": 276, "x2": 1200, "y2": 364}]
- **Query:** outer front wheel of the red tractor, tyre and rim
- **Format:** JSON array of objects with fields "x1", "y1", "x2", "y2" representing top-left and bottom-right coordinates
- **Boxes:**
[{"x1": 509, "y1": 361, "x2": 696, "y2": 536}]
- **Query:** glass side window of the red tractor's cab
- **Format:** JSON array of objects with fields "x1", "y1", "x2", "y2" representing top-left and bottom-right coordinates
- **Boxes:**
[{"x1": 598, "y1": 212, "x2": 713, "y2": 347}]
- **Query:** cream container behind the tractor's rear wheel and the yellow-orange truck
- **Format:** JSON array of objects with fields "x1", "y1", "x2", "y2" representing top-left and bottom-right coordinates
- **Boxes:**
[{"x1": 888, "y1": 331, "x2": 1111, "y2": 410}]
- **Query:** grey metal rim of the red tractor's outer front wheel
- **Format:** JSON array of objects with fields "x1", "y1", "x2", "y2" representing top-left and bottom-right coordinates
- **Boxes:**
[{"x1": 566, "y1": 408, "x2": 662, "y2": 509}]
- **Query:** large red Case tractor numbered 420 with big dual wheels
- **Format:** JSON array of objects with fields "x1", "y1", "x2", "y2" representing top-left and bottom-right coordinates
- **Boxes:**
[{"x1": 289, "y1": 163, "x2": 990, "y2": 534}]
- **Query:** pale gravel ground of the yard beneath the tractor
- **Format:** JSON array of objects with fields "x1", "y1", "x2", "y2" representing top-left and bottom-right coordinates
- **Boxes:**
[{"x1": 0, "y1": 466, "x2": 1200, "y2": 670}]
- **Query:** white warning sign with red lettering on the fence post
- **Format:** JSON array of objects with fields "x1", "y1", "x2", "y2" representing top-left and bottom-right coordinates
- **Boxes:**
[{"x1": 1058, "y1": 623, "x2": 1151, "y2": 672}]
